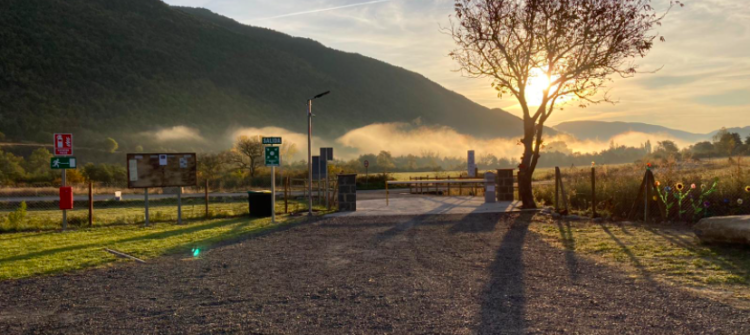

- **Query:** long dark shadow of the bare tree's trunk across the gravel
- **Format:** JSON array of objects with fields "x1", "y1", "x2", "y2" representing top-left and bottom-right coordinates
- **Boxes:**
[{"x1": 478, "y1": 213, "x2": 533, "y2": 334}]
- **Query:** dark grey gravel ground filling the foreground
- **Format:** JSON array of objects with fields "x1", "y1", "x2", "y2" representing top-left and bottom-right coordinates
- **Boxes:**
[{"x1": 0, "y1": 214, "x2": 750, "y2": 334}]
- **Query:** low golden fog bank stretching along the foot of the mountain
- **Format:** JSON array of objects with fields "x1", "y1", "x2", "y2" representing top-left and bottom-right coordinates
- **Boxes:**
[{"x1": 132, "y1": 123, "x2": 692, "y2": 167}]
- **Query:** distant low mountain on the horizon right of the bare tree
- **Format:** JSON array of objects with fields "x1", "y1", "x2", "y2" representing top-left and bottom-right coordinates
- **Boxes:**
[{"x1": 554, "y1": 121, "x2": 711, "y2": 142}]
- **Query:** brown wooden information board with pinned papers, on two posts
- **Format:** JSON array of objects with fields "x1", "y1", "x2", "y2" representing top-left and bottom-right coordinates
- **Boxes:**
[{"x1": 127, "y1": 153, "x2": 198, "y2": 188}]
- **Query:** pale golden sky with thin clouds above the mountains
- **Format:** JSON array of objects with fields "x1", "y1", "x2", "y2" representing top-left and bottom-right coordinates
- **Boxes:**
[{"x1": 165, "y1": 0, "x2": 750, "y2": 133}]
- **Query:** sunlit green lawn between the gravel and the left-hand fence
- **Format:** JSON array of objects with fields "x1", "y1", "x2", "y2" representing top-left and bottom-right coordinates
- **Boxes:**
[{"x1": 0, "y1": 211, "x2": 328, "y2": 280}]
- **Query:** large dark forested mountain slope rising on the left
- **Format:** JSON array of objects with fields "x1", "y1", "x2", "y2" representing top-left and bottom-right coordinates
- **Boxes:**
[{"x1": 0, "y1": 0, "x2": 554, "y2": 150}]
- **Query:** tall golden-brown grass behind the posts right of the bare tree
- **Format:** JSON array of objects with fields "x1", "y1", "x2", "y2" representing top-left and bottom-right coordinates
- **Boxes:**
[{"x1": 534, "y1": 158, "x2": 750, "y2": 222}]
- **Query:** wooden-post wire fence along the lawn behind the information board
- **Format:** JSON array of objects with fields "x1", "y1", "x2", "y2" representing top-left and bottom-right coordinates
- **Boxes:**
[{"x1": 0, "y1": 177, "x2": 337, "y2": 232}]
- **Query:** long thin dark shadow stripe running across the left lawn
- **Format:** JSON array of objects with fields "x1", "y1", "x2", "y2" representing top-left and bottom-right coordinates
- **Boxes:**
[{"x1": 0, "y1": 219, "x2": 252, "y2": 262}]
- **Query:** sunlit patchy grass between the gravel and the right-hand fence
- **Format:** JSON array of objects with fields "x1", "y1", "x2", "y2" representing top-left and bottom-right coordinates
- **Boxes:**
[{"x1": 531, "y1": 222, "x2": 750, "y2": 303}]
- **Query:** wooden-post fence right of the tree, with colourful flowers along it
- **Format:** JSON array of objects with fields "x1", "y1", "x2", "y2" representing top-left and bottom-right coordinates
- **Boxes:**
[{"x1": 534, "y1": 165, "x2": 750, "y2": 222}]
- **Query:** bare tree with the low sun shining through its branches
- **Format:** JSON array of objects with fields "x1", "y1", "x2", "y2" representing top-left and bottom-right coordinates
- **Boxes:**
[{"x1": 449, "y1": 0, "x2": 682, "y2": 208}]
